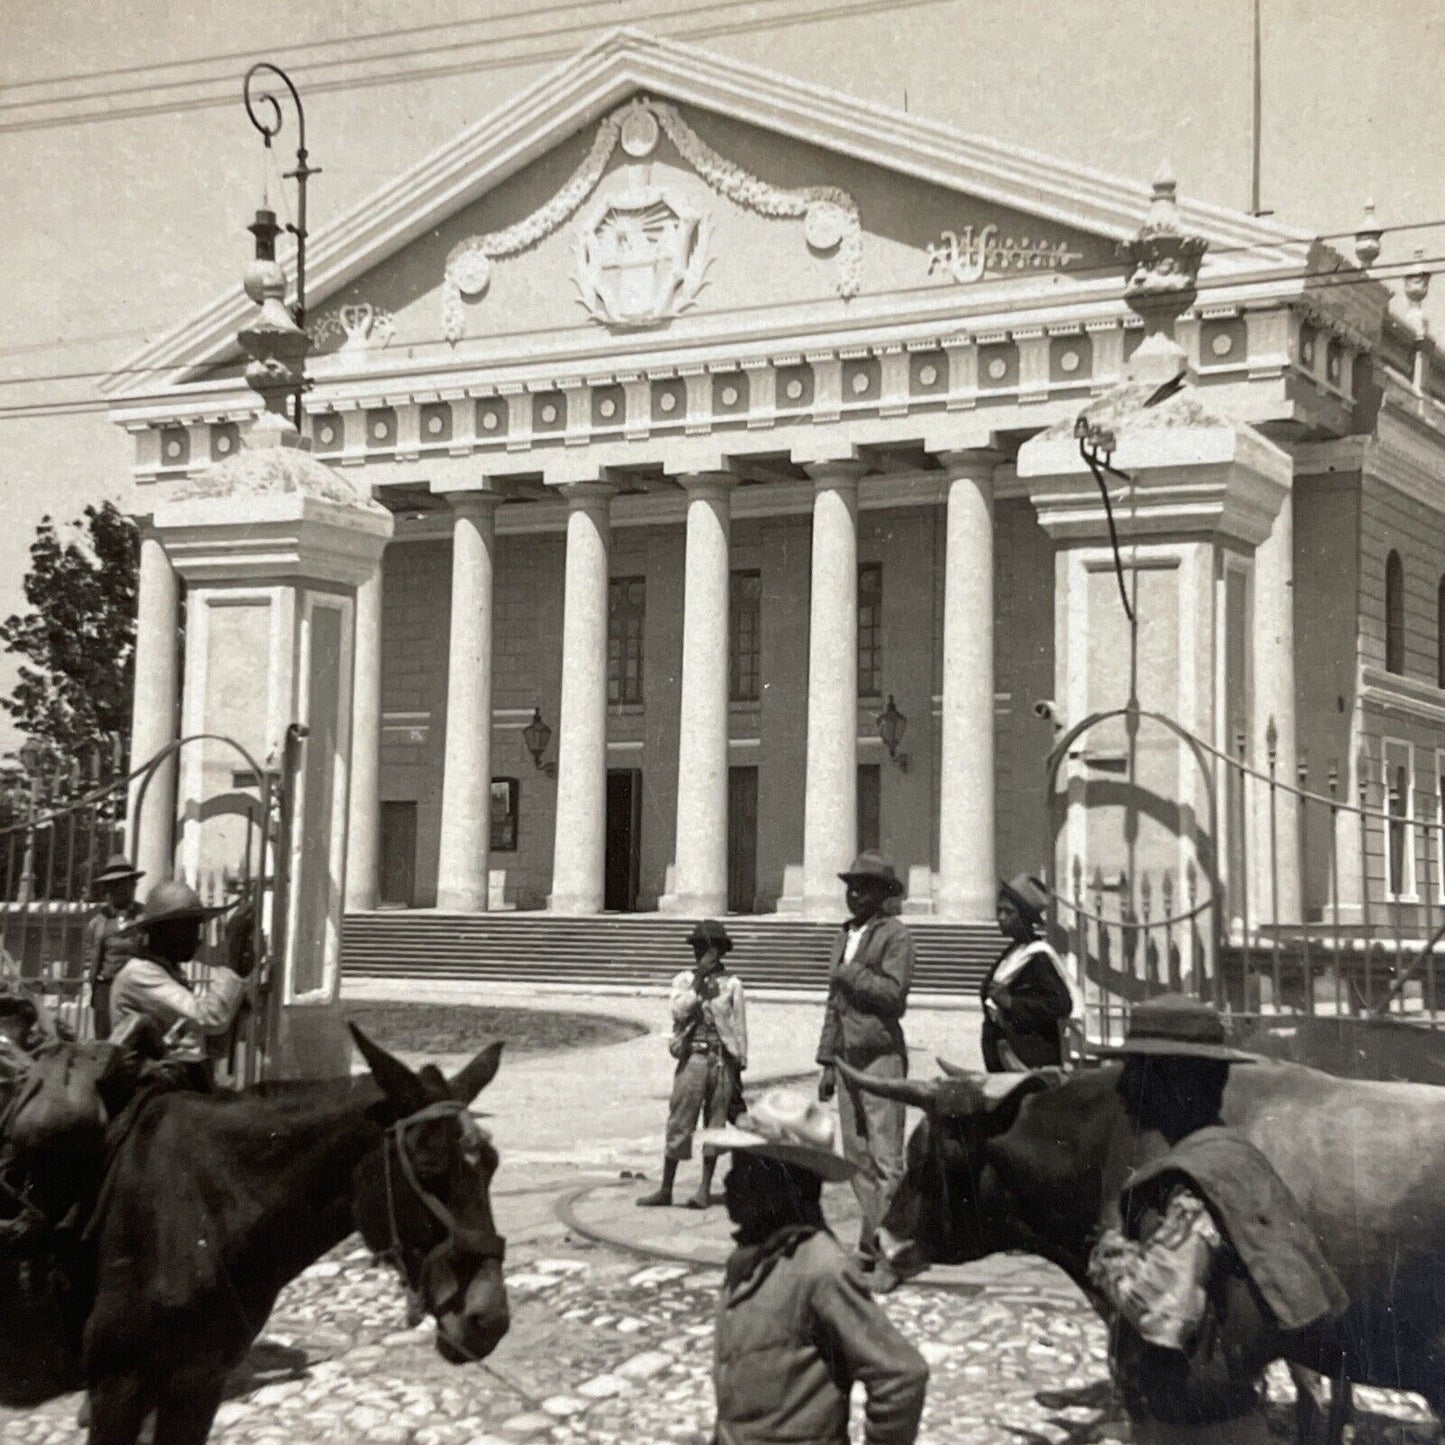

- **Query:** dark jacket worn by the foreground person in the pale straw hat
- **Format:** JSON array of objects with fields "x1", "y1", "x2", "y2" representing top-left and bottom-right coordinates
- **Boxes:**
[{"x1": 714, "y1": 1227, "x2": 928, "y2": 1445}]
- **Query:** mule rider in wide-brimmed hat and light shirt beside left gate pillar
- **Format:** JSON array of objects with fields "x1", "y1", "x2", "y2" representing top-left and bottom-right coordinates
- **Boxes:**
[{"x1": 110, "y1": 879, "x2": 254, "y2": 1062}]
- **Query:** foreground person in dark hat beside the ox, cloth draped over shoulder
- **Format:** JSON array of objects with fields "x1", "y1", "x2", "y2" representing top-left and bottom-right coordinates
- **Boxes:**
[{"x1": 1090, "y1": 994, "x2": 1345, "y2": 1445}]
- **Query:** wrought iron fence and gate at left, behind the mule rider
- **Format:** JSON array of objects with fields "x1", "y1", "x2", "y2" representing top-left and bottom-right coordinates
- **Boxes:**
[{"x1": 0, "y1": 736, "x2": 290, "y2": 1084}]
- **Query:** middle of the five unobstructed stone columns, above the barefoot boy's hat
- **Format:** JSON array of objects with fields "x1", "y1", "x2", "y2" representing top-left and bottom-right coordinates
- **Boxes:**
[{"x1": 662, "y1": 471, "x2": 736, "y2": 916}]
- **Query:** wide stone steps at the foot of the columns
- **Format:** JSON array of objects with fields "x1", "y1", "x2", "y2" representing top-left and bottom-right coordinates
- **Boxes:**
[{"x1": 341, "y1": 909, "x2": 1003, "y2": 998}]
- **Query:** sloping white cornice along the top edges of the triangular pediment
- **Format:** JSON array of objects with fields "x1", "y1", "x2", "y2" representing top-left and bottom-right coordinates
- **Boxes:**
[{"x1": 103, "y1": 30, "x2": 1316, "y2": 399}]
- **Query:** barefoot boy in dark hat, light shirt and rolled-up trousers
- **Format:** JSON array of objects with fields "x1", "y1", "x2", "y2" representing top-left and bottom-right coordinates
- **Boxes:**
[{"x1": 637, "y1": 918, "x2": 747, "y2": 1209}]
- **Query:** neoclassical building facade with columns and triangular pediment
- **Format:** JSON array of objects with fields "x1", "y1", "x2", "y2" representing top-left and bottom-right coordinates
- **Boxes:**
[{"x1": 110, "y1": 32, "x2": 1445, "y2": 936}]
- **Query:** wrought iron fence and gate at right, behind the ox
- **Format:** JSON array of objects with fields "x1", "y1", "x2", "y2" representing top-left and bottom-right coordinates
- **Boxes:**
[{"x1": 1046, "y1": 708, "x2": 1445, "y2": 1042}]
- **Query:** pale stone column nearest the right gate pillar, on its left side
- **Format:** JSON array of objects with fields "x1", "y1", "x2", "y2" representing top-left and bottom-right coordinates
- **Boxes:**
[{"x1": 935, "y1": 449, "x2": 1000, "y2": 922}]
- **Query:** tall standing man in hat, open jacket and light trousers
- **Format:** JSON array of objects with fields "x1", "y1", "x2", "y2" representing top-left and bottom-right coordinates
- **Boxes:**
[{"x1": 818, "y1": 851, "x2": 913, "y2": 1261}]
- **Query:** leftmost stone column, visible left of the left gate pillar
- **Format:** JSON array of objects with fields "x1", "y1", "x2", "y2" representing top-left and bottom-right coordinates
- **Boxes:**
[{"x1": 127, "y1": 526, "x2": 181, "y2": 897}]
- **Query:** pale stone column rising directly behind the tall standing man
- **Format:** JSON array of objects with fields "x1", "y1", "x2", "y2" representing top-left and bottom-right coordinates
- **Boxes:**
[{"x1": 802, "y1": 461, "x2": 863, "y2": 918}]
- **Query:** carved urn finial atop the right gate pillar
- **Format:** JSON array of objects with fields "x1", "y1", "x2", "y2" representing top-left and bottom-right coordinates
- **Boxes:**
[{"x1": 1120, "y1": 162, "x2": 1209, "y2": 381}]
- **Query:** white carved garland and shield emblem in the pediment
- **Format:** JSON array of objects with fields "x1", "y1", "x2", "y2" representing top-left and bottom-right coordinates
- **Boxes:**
[{"x1": 442, "y1": 97, "x2": 863, "y2": 341}]
